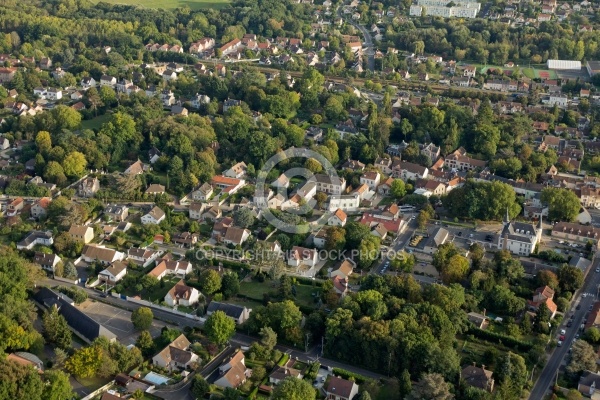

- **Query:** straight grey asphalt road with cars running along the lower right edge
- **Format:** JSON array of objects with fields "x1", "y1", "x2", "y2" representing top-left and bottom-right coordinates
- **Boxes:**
[{"x1": 529, "y1": 254, "x2": 600, "y2": 400}]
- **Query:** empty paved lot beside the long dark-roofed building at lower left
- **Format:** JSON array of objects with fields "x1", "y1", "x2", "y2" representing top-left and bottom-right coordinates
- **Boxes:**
[{"x1": 78, "y1": 300, "x2": 165, "y2": 346}]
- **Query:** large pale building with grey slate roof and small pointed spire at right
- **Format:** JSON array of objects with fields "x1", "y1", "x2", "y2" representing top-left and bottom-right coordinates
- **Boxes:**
[{"x1": 498, "y1": 210, "x2": 542, "y2": 256}]
